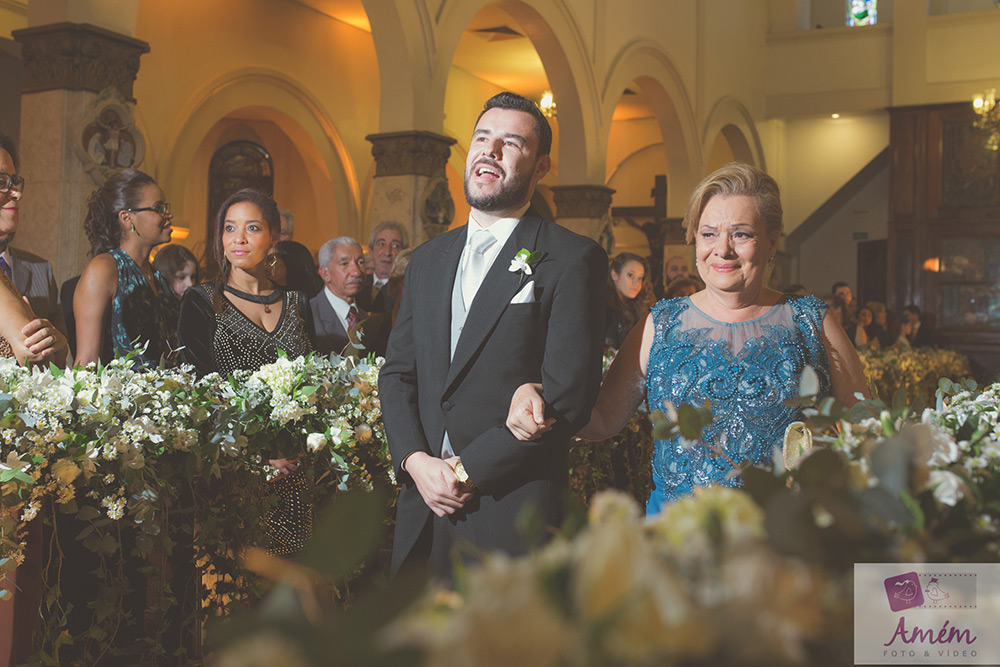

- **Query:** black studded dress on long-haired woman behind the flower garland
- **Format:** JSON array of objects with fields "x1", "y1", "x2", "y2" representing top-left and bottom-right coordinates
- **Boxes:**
[{"x1": 178, "y1": 283, "x2": 314, "y2": 555}]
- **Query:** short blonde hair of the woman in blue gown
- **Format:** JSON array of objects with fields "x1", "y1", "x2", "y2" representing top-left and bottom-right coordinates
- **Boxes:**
[{"x1": 684, "y1": 162, "x2": 782, "y2": 243}]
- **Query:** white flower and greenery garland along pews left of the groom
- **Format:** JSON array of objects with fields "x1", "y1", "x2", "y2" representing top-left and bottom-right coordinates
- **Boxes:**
[{"x1": 0, "y1": 355, "x2": 391, "y2": 563}]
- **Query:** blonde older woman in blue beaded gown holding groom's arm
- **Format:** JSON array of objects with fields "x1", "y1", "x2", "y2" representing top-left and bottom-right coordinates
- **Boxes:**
[{"x1": 507, "y1": 163, "x2": 867, "y2": 514}]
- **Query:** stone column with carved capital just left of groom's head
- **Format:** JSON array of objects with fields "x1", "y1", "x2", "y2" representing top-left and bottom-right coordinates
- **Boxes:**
[{"x1": 366, "y1": 130, "x2": 455, "y2": 248}]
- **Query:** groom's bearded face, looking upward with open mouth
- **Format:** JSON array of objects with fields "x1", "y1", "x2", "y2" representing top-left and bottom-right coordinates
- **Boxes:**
[{"x1": 465, "y1": 108, "x2": 545, "y2": 213}]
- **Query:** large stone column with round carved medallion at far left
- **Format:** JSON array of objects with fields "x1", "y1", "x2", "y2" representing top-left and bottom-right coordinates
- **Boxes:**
[{"x1": 13, "y1": 23, "x2": 149, "y2": 282}]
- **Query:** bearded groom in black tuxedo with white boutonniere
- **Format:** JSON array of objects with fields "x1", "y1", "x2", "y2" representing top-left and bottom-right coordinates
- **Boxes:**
[{"x1": 379, "y1": 93, "x2": 608, "y2": 579}]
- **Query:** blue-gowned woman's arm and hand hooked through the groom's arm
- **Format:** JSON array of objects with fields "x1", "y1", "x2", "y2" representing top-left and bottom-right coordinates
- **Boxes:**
[{"x1": 507, "y1": 315, "x2": 656, "y2": 441}]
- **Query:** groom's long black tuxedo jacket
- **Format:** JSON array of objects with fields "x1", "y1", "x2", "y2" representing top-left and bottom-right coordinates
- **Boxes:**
[{"x1": 379, "y1": 211, "x2": 608, "y2": 572}]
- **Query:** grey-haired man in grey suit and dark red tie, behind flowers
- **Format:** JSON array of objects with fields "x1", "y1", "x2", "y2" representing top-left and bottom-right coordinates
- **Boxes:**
[{"x1": 309, "y1": 236, "x2": 378, "y2": 355}]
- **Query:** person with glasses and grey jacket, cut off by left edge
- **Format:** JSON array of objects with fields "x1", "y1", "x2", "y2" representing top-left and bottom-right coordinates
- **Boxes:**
[{"x1": 0, "y1": 132, "x2": 66, "y2": 334}]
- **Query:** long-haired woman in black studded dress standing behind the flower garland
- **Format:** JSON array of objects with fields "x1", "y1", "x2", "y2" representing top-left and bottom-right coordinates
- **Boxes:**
[{"x1": 178, "y1": 189, "x2": 313, "y2": 554}]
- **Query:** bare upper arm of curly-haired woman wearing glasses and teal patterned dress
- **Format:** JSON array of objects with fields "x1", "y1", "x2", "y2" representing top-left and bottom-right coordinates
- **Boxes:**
[{"x1": 73, "y1": 254, "x2": 118, "y2": 366}]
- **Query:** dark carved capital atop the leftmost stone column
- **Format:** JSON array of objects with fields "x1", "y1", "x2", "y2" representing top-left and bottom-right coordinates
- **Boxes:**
[{"x1": 12, "y1": 23, "x2": 149, "y2": 102}]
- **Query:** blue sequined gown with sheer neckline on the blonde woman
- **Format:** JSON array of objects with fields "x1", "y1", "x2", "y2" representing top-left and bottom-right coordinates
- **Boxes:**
[{"x1": 646, "y1": 296, "x2": 830, "y2": 514}]
